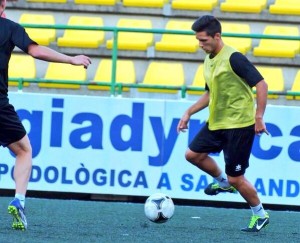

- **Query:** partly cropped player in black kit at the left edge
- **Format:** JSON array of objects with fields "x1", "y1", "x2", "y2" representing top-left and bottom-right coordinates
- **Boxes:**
[{"x1": 0, "y1": 0, "x2": 91, "y2": 230}]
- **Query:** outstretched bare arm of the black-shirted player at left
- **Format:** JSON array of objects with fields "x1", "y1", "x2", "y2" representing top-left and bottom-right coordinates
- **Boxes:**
[{"x1": 28, "y1": 44, "x2": 92, "y2": 68}]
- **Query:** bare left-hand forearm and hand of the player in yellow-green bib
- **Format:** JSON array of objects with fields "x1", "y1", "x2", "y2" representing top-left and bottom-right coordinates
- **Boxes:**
[{"x1": 177, "y1": 91, "x2": 209, "y2": 133}]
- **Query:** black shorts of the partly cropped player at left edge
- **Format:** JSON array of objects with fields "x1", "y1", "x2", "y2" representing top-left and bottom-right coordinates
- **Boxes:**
[{"x1": 0, "y1": 104, "x2": 26, "y2": 147}]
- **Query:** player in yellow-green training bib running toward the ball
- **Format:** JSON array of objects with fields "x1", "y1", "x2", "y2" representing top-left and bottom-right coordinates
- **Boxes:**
[{"x1": 177, "y1": 15, "x2": 269, "y2": 232}]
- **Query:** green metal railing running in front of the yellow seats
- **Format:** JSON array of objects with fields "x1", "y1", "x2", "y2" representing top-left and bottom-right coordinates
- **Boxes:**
[{"x1": 9, "y1": 24, "x2": 300, "y2": 98}]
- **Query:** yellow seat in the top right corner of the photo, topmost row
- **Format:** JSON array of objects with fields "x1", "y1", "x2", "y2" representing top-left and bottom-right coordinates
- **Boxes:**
[{"x1": 269, "y1": 0, "x2": 300, "y2": 15}]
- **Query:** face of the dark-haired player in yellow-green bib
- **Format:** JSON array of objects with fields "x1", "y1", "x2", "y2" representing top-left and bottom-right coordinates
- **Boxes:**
[{"x1": 196, "y1": 31, "x2": 220, "y2": 54}]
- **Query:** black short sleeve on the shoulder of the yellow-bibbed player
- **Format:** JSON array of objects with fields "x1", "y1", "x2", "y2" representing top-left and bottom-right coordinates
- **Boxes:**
[{"x1": 205, "y1": 52, "x2": 264, "y2": 90}]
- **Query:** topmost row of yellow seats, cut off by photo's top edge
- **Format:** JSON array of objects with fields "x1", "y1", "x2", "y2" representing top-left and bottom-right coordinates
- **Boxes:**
[{"x1": 27, "y1": 0, "x2": 300, "y2": 15}]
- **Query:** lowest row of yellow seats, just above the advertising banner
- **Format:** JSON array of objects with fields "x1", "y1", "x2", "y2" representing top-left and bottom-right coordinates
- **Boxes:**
[{"x1": 9, "y1": 54, "x2": 300, "y2": 99}]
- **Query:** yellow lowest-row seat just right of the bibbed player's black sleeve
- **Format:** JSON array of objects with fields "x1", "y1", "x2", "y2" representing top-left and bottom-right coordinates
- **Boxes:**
[{"x1": 254, "y1": 66, "x2": 284, "y2": 99}]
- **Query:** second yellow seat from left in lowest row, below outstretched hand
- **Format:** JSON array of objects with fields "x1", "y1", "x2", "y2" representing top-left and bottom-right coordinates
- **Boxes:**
[{"x1": 38, "y1": 62, "x2": 86, "y2": 89}]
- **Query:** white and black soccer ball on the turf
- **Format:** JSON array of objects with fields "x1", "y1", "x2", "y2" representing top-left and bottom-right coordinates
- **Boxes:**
[{"x1": 144, "y1": 193, "x2": 175, "y2": 223}]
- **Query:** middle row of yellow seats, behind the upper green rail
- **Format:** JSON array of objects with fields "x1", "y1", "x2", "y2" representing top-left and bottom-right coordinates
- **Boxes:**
[{"x1": 19, "y1": 13, "x2": 300, "y2": 58}]
